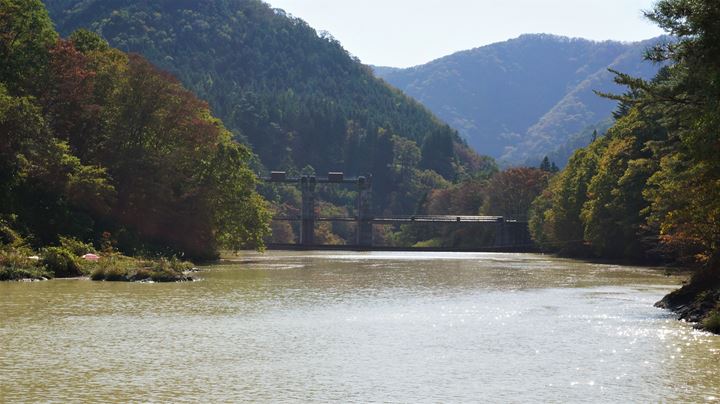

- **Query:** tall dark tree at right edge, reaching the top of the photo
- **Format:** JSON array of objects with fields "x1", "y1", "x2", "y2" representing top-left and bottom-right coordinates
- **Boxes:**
[{"x1": 617, "y1": 0, "x2": 720, "y2": 261}]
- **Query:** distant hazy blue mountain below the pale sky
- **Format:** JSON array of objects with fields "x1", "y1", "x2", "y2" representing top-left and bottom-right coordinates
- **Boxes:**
[{"x1": 375, "y1": 35, "x2": 658, "y2": 165}]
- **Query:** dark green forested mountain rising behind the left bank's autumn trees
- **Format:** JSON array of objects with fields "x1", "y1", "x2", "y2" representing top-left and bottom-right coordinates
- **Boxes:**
[{"x1": 45, "y1": 0, "x2": 486, "y2": 215}]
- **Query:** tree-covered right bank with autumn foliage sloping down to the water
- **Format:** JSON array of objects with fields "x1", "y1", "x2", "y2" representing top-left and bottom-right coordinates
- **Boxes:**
[{"x1": 531, "y1": 0, "x2": 720, "y2": 332}]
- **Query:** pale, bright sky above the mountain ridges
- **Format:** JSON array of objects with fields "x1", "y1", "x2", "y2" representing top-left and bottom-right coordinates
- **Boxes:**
[{"x1": 265, "y1": 0, "x2": 663, "y2": 67}]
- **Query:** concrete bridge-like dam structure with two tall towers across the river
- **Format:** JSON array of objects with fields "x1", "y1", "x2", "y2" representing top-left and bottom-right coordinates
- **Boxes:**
[{"x1": 261, "y1": 171, "x2": 532, "y2": 250}]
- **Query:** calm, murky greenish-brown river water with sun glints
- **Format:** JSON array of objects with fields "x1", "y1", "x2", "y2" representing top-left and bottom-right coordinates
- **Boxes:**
[{"x1": 0, "y1": 252, "x2": 720, "y2": 402}]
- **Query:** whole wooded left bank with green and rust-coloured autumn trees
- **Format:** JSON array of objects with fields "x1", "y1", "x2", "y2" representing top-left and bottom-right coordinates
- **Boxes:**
[{"x1": 0, "y1": 0, "x2": 269, "y2": 270}]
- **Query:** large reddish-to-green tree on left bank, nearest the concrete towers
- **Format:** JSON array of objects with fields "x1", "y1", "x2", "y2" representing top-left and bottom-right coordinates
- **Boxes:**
[{"x1": 99, "y1": 56, "x2": 269, "y2": 258}]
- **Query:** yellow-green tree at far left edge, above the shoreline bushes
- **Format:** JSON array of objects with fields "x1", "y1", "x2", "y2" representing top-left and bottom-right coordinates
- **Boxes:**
[{"x1": 0, "y1": 85, "x2": 115, "y2": 243}]
